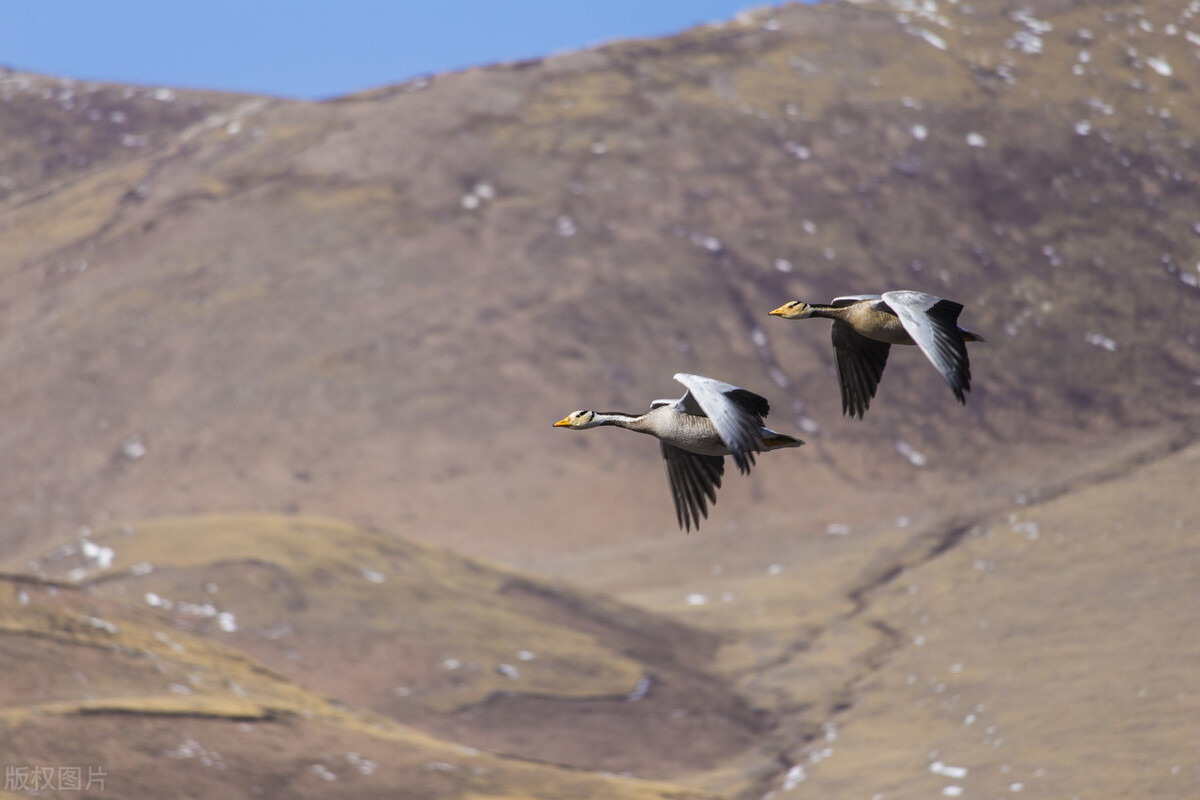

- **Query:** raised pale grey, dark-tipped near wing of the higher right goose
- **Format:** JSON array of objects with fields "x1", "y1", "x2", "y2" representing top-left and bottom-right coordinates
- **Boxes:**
[{"x1": 881, "y1": 291, "x2": 971, "y2": 404}]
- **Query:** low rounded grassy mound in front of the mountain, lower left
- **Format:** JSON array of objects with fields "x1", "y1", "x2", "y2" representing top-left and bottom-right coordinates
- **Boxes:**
[{"x1": 7, "y1": 517, "x2": 761, "y2": 776}]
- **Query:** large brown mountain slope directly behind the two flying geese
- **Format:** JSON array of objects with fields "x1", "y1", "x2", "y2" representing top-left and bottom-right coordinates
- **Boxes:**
[{"x1": 0, "y1": 4, "x2": 1200, "y2": 558}]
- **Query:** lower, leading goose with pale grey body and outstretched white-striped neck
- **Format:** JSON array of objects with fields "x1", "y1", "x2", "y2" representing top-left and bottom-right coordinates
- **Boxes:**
[{"x1": 554, "y1": 372, "x2": 804, "y2": 531}]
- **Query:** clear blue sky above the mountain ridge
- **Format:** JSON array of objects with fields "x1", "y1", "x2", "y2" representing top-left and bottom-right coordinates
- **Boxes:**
[{"x1": 0, "y1": 0, "x2": 782, "y2": 100}]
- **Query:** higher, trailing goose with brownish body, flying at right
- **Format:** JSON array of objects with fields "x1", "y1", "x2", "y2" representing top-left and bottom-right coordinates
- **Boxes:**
[{"x1": 770, "y1": 291, "x2": 986, "y2": 419}]
